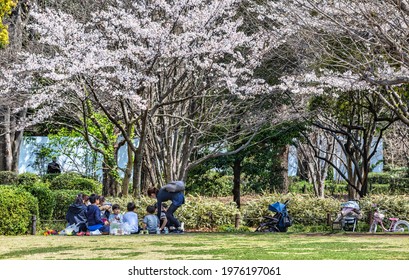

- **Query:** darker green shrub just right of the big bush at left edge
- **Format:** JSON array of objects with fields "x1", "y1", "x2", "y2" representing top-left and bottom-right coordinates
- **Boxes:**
[{"x1": 23, "y1": 182, "x2": 56, "y2": 220}]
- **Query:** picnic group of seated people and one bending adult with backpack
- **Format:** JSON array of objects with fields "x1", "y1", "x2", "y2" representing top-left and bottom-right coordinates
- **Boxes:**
[{"x1": 58, "y1": 181, "x2": 185, "y2": 236}]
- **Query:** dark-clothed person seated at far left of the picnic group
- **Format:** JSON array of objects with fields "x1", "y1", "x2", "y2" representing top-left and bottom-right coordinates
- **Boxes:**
[{"x1": 65, "y1": 193, "x2": 87, "y2": 233}]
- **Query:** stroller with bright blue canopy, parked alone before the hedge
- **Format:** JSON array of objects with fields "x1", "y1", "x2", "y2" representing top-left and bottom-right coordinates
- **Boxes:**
[{"x1": 256, "y1": 200, "x2": 292, "y2": 232}]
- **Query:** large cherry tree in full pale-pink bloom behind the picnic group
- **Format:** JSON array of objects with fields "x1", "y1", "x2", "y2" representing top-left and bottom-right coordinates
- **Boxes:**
[{"x1": 14, "y1": 0, "x2": 285, "y2": 194}]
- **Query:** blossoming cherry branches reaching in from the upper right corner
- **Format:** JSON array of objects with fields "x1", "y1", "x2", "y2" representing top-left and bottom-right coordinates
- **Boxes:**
[{"x1": 269, "y1": 0, "x2": 409, "y2": 125}]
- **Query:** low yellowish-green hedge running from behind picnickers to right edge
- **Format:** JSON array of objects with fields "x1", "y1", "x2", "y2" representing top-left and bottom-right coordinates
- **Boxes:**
[{"x1": 91, "y1": 193, "x2": 409, "y2": 232}]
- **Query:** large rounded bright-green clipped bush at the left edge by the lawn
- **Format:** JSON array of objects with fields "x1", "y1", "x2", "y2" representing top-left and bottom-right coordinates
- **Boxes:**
[{"x1": 0, "y1": 186, "x2": 38, "y2": 235}]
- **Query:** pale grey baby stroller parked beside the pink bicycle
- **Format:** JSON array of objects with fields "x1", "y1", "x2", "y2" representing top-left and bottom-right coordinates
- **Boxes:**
[{"x1": 332, "y1": 200, "x2": 362, "y2": 232}]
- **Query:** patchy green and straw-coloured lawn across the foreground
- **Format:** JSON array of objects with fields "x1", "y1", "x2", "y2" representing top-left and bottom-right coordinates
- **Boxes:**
[{"x1": 0, "y1": 233, "x2": 409, "y2": 260}]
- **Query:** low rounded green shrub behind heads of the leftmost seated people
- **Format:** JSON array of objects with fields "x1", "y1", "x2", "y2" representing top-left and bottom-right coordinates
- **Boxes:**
[{"x1": 50, "y1": 172, "x2": 102, "y2": 194}]
